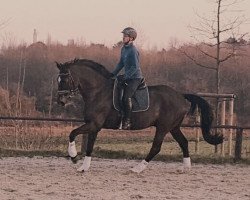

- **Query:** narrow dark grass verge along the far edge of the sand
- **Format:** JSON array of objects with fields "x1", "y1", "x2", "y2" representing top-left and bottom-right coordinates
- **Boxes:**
[{"x1": 0, "y1": 147, "x2": 250, "y2": 165}]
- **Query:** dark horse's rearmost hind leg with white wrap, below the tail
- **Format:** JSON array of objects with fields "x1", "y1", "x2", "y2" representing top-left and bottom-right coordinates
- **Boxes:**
[{"x1": 170, "y1": 127, "x2": 191, "y2": 169}]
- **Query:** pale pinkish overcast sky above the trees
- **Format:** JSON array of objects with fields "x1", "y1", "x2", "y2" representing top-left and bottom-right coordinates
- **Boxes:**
[{"x1": 0, "y1": 0, "x2": 250, "y2": 48}]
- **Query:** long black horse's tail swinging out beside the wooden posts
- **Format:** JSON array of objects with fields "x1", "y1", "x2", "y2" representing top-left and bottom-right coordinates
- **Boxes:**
[{"x1": 184, "y1": 94, "x2": 223, "y2": 145}]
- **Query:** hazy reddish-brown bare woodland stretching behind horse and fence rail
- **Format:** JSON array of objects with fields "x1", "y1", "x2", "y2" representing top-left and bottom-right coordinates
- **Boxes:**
[{"x1": 0, "y1": 42, "x2": 250, "y2": 125}]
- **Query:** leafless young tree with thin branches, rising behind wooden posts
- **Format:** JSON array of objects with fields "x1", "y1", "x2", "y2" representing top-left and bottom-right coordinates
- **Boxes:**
[{"x1": 179, "y1": 0, "x2": 247, "y2": 94}]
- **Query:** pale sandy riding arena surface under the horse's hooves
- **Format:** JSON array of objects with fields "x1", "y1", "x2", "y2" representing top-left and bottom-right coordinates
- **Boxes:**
[{"x1": 0, "y1": 157, "x2": 250, "y2": 200}]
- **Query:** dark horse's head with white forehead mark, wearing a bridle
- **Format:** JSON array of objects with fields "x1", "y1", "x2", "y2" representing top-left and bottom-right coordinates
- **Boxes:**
[{"x1": 56, "y1": 62, "x2": 78, "y2": 106}]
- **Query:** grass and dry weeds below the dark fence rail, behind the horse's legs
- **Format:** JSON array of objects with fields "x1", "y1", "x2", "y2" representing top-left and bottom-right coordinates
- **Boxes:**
[{"x1": 0, "y1": 127, "x2": 250, "y2": 164}]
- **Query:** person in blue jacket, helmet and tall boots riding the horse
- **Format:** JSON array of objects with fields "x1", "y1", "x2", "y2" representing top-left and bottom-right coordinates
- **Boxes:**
[{"x1": 112, "y1": 27, "x2": 143, "y2": 130}]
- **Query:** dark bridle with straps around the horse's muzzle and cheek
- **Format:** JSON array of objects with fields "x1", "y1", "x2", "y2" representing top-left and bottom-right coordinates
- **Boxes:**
[{"x1": 57, "y1": 72, "x2": 79, "y2": 97}]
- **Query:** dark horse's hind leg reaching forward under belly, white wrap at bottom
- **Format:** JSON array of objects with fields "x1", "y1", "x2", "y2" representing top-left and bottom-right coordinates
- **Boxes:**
[{"x1": 131, "y1": 128, "x2": 167, "y2": 173}]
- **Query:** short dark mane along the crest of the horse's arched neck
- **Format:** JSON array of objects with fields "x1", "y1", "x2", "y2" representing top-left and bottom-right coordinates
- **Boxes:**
[{"x1": 63, "y1": 59, "x2": 110, "y2": 78}]
